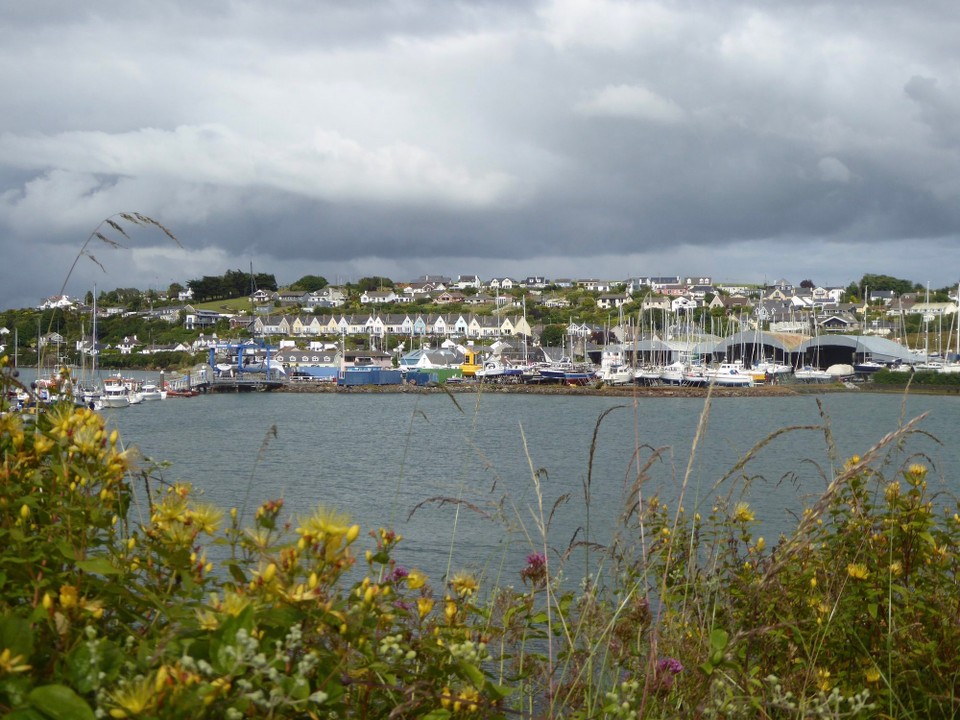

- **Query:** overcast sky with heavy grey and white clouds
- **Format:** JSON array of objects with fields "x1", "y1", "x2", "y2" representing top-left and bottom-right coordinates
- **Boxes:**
[{"x1": 0, "y1": 0, "x2": 960, "y2": 308}]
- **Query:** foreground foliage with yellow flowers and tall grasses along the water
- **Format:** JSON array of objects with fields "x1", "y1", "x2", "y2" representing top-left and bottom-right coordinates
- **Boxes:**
[{"x1": 0, "y1": 368, "x2": 960, "y2": 720}]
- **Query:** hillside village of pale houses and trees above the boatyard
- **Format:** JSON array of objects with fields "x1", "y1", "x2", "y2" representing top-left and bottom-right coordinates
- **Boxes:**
[{"x1": 15, "y1": 275, "x2": 958, "y2": 368}]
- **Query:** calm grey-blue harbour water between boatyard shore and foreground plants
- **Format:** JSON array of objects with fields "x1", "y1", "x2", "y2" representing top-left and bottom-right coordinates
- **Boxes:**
[{"x1": 99, "y1": 392, "x2": 960, "y2": 582}]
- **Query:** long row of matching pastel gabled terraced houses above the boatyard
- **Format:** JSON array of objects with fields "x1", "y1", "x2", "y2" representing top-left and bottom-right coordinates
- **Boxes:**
[{"x1": 244, "y1": 313, "x2": 536, "y2": 339}]
